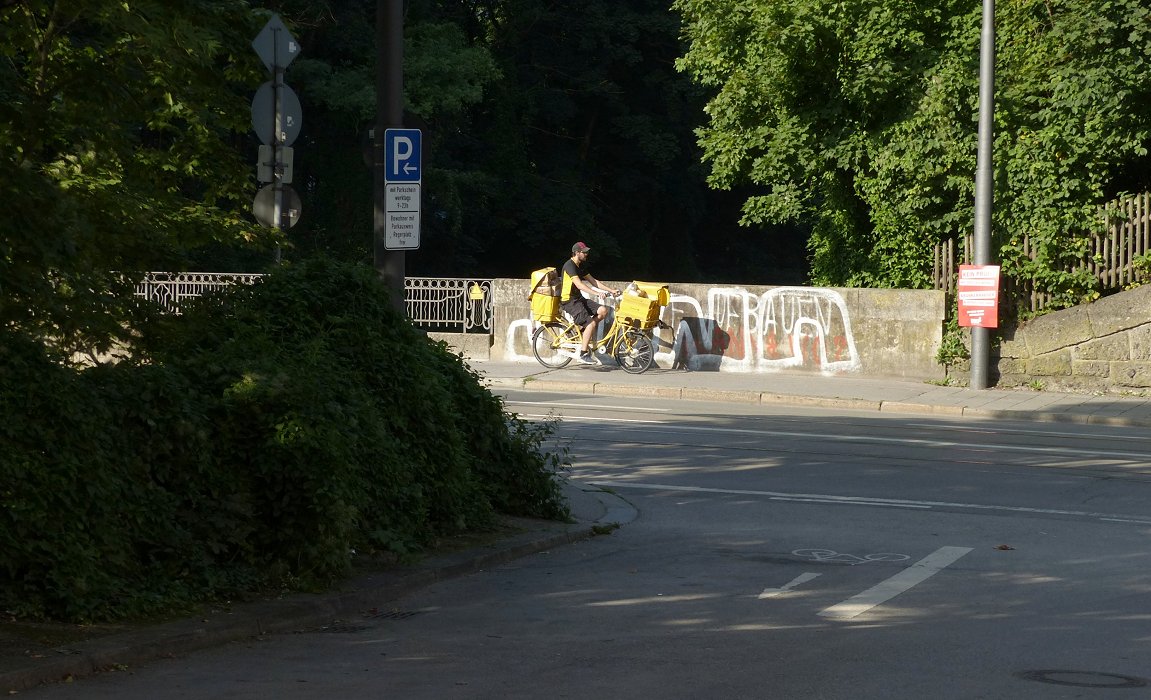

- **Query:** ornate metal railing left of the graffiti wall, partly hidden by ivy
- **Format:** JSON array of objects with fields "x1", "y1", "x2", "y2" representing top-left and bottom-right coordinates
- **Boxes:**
[{"x1": 136, "y1": 272, "x2": 493, "y2": 333}]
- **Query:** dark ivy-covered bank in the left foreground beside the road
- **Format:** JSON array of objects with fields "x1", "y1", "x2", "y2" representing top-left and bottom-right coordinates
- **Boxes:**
[{"x1": 0, "y1": 261, "x2": 567, "y2": 621}]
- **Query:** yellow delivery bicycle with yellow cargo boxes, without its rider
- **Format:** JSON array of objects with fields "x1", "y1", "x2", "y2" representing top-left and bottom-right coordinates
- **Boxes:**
[{"x1": 529, "y1": 271, "x2": 669, "y2": 374}]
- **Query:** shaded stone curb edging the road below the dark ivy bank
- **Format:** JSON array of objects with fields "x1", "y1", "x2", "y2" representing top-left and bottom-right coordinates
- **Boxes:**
[{"x1": 0, "y1": 487, "x2": 637, "y2": 694}]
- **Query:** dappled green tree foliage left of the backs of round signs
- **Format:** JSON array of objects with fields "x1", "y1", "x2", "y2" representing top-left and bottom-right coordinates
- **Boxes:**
[{"x1": 0, "y1": 0, "x2": 266, "y2": 350}]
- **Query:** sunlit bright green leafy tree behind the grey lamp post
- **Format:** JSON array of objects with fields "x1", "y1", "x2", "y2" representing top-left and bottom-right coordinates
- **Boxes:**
[{"x1": 674, "y1": 0, "x2": 1151, "y2": 304}]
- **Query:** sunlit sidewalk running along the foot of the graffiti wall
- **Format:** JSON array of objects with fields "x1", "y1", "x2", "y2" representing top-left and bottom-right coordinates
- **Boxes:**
[{"x1": 471, "y1": 360, "x2": 1151, "y2": 427}]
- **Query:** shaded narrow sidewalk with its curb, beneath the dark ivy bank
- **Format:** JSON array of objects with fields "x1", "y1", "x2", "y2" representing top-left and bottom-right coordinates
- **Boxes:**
[{"x1": 0, "y1": 481, "x2": 635, "y2": 694}]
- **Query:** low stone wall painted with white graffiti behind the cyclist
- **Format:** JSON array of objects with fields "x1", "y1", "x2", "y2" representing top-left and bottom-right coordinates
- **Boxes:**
[{"x1": 490, "y1": 280, "x2": 945, "y2": 380}]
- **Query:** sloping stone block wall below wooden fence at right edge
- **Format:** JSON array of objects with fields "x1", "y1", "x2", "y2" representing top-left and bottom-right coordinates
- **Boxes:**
[{"x1": 990, "y1": 286, "x2": 1151, "y2": 394}]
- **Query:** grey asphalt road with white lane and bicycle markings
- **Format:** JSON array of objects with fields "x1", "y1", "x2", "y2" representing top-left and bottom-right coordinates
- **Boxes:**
[{"x1": 24, "y1": 393, "x2": 1151, "y2": 700}]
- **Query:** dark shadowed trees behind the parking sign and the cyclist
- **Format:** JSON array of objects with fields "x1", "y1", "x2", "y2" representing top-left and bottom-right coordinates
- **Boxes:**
[{"x1": 282, "y1": 0, "x2": 779, "y2": 281}]
